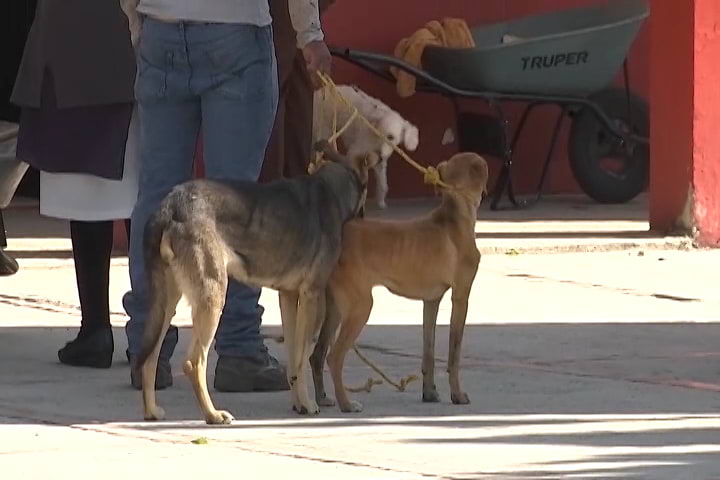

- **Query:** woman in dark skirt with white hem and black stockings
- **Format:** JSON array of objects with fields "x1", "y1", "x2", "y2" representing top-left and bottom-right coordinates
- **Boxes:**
[{"x1": 12, "y1": 0, "x2": 138, "y2": 368}]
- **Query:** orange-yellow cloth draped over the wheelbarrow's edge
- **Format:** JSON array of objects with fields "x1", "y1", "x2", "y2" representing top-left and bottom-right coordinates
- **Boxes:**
[{"x1": 390, "y1": 18, "x2": 475, "y2": 98}]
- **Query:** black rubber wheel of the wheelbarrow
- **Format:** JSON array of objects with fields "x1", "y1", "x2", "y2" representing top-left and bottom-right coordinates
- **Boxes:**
[{"x1": 569, "y1": 88, "x2": 650, "y2": 203}]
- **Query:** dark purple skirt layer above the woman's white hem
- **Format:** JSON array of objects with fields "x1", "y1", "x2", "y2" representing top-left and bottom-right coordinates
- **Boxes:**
[{"x1": 17, "y1": 72, "x2": 133, "y2": 180}]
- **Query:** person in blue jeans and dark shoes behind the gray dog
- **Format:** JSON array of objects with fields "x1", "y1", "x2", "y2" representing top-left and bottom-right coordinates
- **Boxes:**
[{"x1": 123, "y1": 0, "x2": 331, "y2": 392}]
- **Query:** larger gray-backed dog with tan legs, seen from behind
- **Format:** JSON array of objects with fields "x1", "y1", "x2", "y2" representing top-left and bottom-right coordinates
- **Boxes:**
[{"x1": 138, "y1": 142, "x2": 371, "y2": 424}]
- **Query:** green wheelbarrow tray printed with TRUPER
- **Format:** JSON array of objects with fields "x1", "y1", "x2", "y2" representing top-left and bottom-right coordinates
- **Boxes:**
[{"x1": 422, "y1": 0, "x2": 648, "y2": 96}]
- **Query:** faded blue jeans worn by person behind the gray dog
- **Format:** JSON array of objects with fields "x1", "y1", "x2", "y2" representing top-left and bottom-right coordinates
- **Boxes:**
[{"x1": 123, "y1": 18, "x2": 278, "y2": 358}]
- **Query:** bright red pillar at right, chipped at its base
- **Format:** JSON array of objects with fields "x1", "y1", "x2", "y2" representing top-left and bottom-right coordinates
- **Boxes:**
[{"x1": 650, "y1": 0, "x2": 720, "y2": 247}]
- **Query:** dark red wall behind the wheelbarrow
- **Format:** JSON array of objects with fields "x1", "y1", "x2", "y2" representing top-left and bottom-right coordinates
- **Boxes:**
[{"x1": 323, "y1": 0, "x2": 652, "y2": 197}]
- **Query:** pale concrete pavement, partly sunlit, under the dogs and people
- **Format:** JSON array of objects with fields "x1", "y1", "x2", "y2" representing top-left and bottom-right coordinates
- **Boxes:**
[{"x1": 0, "y1": 196, "x2": 720, "y2": 480}]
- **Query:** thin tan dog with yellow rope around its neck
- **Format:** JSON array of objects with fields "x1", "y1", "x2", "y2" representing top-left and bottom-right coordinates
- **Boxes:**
[{"x1": 310, "y1": 153, "x2": 488, "y2": 412}]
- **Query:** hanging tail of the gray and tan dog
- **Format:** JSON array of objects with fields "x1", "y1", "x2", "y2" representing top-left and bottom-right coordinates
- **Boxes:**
[{"x1": 137, "y1": 211, "x2": 178, "y2": 366}]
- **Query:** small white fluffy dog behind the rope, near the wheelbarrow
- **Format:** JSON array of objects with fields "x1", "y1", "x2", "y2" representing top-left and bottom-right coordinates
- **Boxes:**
[{"x1": 313, "y1": 85, "x2": 420, "y2": 208}]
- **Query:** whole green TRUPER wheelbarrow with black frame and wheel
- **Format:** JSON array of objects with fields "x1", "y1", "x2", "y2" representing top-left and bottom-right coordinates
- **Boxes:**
[{"x1": 331, "y1": 0, "x2": 650, "y2": 210}]
